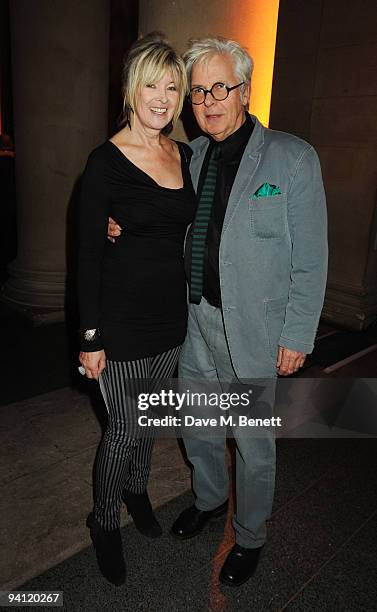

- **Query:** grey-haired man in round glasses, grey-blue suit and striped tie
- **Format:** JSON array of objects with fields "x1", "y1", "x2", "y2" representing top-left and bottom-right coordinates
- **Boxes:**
[{"x1": 108, "y1": 38, "x2": 327, "y2": 586}]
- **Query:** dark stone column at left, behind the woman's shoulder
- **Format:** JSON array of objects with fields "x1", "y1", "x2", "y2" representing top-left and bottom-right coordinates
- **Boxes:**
[{"x1": 2, "y1": 0, "x2": 109, "y2": 318}]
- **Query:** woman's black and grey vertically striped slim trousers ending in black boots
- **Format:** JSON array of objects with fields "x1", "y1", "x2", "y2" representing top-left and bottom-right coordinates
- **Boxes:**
[{"x1": 94, "y1": 346, "x2": 181, "y2": 530}]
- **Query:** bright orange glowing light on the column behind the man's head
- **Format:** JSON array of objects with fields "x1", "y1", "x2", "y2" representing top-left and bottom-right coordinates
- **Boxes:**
[{"x1": 226, "y1": 0, "x2": 279, "y2": 127}]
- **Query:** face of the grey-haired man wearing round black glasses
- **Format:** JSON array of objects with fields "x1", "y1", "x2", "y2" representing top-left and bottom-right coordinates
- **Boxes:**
[{"x1": 191, "y1": 54, "x2": 250, "y2": 141}]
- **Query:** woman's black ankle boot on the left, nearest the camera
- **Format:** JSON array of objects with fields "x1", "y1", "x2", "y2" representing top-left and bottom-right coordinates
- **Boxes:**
[{"x1": 86, "y1": 512, "x2": 126, "y2": 586}]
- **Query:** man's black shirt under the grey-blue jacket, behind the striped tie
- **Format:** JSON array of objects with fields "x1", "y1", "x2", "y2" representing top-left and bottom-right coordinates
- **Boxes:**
[{"x1": 197, "y1": 113, "x2": 254, "y2": 306}]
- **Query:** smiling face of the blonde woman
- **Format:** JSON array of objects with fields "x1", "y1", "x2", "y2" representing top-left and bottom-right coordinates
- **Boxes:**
[{"x1": 134, "y1": 72, "x2": 179, "y2": 131}]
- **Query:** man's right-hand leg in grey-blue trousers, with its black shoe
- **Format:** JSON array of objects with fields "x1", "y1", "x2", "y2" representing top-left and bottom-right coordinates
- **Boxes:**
[{"x1": 206, "y1": 320, "x2": 275, "y2": 586}]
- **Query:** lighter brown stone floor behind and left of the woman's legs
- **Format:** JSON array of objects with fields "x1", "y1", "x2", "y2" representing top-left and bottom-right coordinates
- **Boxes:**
[{"x1": 0, "y1": 388, "x2": 190, "y2": 590}]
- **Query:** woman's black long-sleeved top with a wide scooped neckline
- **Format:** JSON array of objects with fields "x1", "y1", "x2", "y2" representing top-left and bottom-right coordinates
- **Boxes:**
[{"x1": 78, "y1": 141, "x2": 197, "y2": 361}]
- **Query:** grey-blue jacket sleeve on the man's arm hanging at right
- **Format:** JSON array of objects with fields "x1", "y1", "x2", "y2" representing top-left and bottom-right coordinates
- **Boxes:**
[{"x1": 279, "y1": 146, "x2": 328, "y2": 353}]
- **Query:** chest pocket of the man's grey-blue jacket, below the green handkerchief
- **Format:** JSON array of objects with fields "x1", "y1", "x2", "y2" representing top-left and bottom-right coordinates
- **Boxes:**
[{"x1": 249, "y1": 194, "x2": 286, "y2": 240}]
